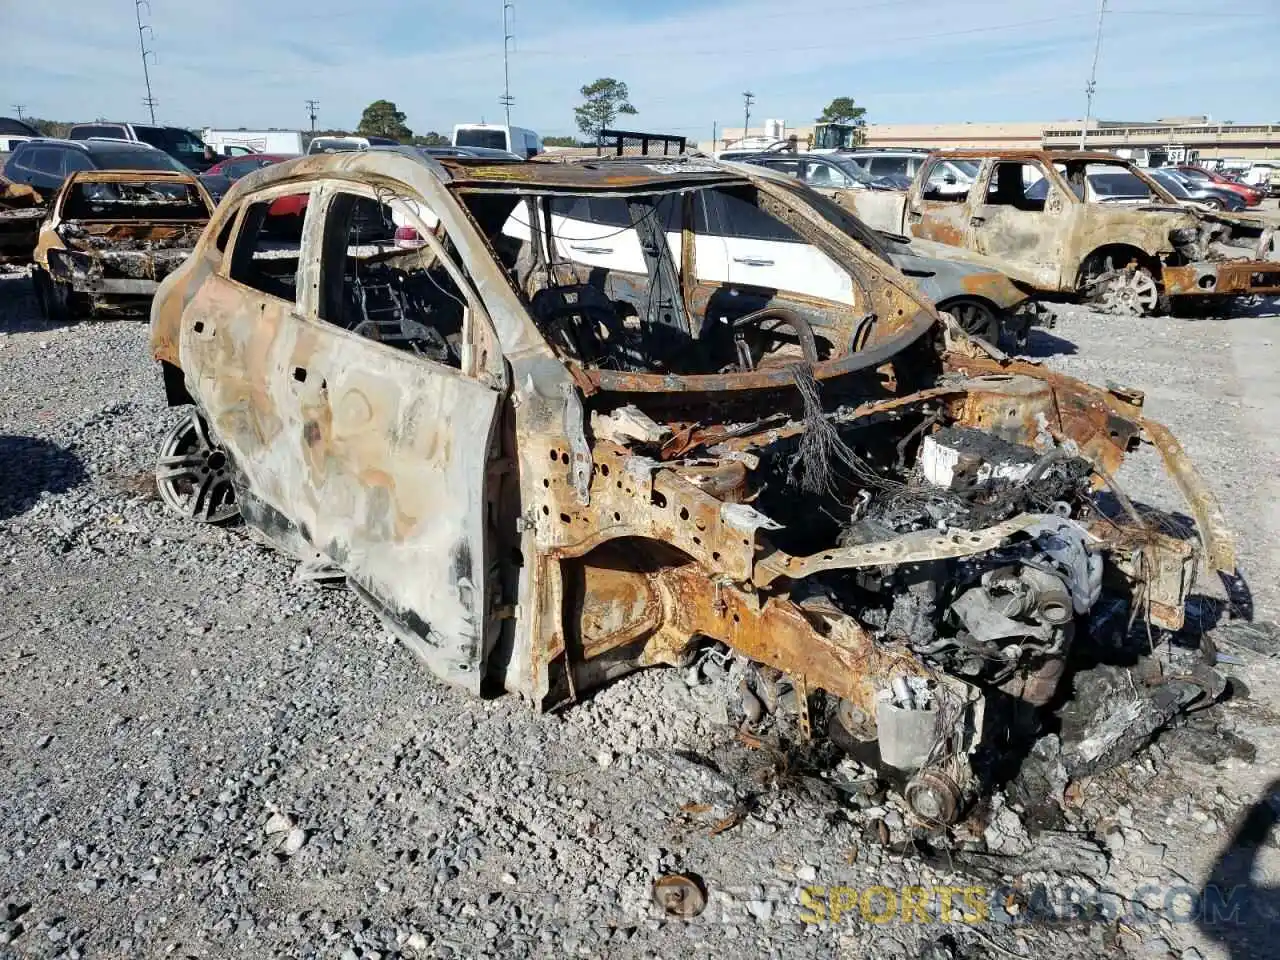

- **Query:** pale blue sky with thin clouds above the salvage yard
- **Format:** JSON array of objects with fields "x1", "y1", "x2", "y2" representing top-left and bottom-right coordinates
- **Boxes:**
[{"x1": 0, "y1": 0, "x2": 1280, "y2": 138}]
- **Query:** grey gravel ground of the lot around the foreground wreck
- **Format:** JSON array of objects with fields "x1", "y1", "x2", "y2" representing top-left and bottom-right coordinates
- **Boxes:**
[{"x1": 0, "y1": 264, "x2": 1280, "y2": 960}]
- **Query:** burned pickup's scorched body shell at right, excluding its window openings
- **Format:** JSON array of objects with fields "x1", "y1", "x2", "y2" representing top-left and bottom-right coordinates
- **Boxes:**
[{"x1": 842, "y1": 150, "x2": 1280, "y2": 309}]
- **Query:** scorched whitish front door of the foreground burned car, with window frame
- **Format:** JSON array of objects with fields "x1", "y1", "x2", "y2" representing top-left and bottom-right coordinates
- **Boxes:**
[{"x1": 280, "y1": 182, "x2": 504, "y2": 694}]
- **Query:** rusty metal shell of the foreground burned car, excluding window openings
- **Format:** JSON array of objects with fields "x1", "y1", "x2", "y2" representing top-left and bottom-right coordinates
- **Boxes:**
[{"x1": 151, "y1": 152, "x2": 1234, "y2": 820}]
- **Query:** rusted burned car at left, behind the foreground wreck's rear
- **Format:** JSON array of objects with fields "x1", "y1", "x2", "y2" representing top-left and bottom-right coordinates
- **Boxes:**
[{"x1": 33, "y1": 170, "x2": 214, "y2": 319}]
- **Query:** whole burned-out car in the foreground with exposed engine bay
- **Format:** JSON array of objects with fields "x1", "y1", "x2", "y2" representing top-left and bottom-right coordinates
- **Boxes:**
[{"x1": 151, "y1": 152, "x2": 1234, "y2": 820}]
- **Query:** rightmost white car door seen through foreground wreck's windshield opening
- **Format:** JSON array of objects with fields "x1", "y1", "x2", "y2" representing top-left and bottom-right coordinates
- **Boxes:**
[{"x1": 707, "y1": 189, "x2": 854, "y2": 303}]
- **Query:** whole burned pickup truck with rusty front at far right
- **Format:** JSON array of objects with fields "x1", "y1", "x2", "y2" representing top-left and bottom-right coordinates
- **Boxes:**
[{"x1": 836, "y1": 150, "x2": 1280, "y2": 316}]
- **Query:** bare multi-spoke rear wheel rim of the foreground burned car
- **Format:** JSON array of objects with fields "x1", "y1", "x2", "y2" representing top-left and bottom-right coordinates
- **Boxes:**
[{"x1": 156, "y1": 413, "x2": 239, "y2": 524}]
